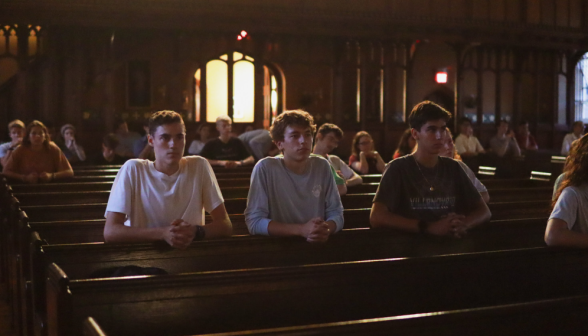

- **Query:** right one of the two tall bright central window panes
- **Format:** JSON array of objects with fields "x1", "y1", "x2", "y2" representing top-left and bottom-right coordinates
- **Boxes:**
[{"x1": 233, "y1": 61, "x2": 255, "y2": 122}]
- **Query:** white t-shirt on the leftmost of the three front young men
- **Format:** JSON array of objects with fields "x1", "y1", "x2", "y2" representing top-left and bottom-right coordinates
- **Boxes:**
[{"x1": 104, "y1": 156, "x2": 224, "y2": 228}]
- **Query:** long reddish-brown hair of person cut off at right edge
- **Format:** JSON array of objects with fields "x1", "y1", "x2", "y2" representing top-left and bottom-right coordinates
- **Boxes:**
[{"x1": 551, "y1": 136, "x2": 588, "y2": 210}]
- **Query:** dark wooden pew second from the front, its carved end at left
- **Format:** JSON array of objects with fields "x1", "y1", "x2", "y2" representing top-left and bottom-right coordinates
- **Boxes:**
[{"x1": 47, "y1": 248, "x2": 588, "y2": 335}]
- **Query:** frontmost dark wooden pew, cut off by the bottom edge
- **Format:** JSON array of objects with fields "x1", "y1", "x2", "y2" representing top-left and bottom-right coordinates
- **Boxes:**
[{"x1": 83, "y1": 295, "x2": 588, "y2": 336}]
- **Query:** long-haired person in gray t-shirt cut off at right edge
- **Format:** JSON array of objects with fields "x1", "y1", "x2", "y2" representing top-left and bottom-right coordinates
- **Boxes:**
[{"x1": 545, "y1": 137, "x2": 588, "y2": 248}]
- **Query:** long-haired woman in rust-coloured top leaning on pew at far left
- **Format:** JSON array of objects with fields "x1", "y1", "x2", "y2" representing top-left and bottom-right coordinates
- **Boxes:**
[{"x1": 2, "y1": 120, "x2": 73, "y2": 183}]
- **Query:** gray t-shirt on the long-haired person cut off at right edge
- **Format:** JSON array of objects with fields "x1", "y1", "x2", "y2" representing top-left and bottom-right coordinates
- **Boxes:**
[{"x1": 549, "y1": 184, "x2": 588, "y2": 233}]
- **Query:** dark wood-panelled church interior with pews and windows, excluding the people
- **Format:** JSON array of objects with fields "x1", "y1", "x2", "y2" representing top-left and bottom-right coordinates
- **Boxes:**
[{"x1": 0, "y1": 0, "x2": 588, "y2": 336}]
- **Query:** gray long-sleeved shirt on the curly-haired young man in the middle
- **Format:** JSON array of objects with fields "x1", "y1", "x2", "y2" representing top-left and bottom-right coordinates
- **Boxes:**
[{"x1": 245, "y1": 156, "x2": 343, "y2": 235}]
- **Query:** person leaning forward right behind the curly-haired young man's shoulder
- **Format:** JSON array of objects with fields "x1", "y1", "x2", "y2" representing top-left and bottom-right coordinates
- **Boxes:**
[{"x1": 312, "y1": 124, "x2": 363, "y2": 189}]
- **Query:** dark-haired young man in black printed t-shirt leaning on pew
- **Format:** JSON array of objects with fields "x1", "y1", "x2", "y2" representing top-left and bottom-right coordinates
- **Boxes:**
[{"x1": 370, "y1": 101, "x2": 491, "y2": 238}]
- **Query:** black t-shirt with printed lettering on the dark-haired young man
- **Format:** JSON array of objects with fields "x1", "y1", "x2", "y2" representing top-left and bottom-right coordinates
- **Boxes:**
[{"x1": 374, "y1": 155, "x2": 481, "y2": 222}]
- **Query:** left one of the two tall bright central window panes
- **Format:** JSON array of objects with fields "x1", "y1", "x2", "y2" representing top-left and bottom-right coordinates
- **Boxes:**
[{"x1": 206, "y1": 60, "x2": 229, "y2": 122}]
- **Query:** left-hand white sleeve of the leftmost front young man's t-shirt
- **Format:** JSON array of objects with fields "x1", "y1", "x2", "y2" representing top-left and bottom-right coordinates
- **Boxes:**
[{"x1": 104, "y1": 160, "x2": 137, "y2": 219}]
